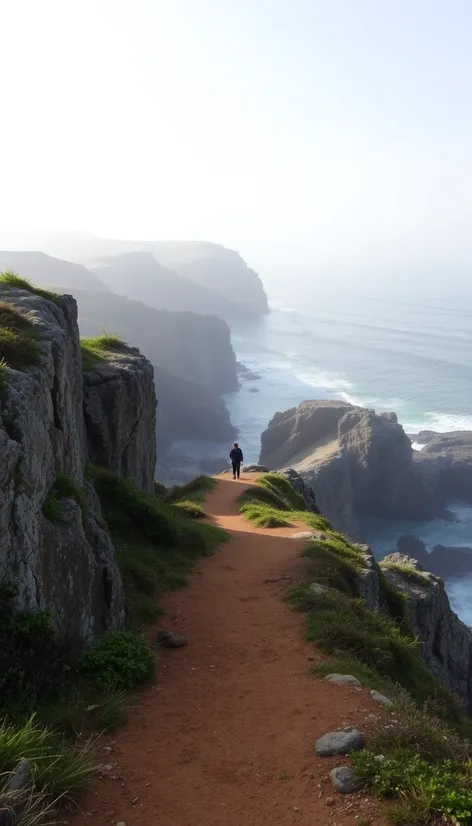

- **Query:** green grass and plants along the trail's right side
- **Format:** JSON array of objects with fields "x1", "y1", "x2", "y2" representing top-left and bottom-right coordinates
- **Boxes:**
[{"x1": 245, "y1": 474, "x2": 472, "y2": 826}]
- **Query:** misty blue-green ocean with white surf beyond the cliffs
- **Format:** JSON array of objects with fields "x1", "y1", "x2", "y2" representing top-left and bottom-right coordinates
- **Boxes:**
[{"x1": 225, "y1": 295, "x2": 472, "y2": 626}]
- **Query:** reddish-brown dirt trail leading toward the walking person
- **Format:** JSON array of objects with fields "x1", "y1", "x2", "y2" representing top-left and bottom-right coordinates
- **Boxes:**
[{"x1": 73, "y1": 474, "x2": 380, "y2": 826}]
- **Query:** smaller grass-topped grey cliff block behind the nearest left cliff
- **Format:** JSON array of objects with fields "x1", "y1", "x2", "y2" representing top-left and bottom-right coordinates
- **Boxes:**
[{"x1": 84, "y1": 348, "x2": 157, "y2": 492}]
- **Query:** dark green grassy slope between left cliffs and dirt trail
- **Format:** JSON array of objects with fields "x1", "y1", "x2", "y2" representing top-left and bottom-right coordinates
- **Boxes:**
[{"x1": 88, "y1": 466, "x2": 228, "y2": 626}]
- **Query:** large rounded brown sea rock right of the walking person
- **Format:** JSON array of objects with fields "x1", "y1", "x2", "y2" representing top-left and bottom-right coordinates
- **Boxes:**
[{"x1": 260, "y1": 401, "x2": 436, "y2": 537}]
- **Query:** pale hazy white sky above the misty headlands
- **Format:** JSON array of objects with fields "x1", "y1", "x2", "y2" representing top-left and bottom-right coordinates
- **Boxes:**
[{"x1": 0, "y1": 0, "x2": 472, "y2": 288}]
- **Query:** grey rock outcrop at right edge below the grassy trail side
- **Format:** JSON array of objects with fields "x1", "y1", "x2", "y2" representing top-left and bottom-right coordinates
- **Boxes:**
[{"x1": 381, "y1": 554, "x2": 472, "y2": 709}]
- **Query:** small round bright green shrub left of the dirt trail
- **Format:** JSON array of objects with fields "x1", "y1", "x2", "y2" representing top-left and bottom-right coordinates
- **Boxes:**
[{"x1": 81, "y1": 631, "x2": 155, "y2": 691}]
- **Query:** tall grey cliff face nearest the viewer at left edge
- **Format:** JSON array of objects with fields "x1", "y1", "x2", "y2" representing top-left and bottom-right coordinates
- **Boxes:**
[{"x1": 0, "y1": 289, "x2": 124, "y2": 636}]
